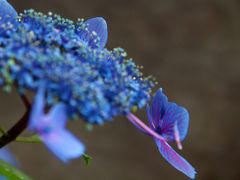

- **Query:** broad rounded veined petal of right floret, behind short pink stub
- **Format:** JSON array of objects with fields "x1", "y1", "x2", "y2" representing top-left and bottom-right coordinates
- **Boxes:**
[{"x1": 161, "y1": 102, "x2": 189, "y2": 142}]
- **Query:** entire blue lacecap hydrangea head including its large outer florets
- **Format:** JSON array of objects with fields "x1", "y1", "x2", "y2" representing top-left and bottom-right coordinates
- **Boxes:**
[{"x1": 0, "y1": 0, "x2": 196, "y2": 179}]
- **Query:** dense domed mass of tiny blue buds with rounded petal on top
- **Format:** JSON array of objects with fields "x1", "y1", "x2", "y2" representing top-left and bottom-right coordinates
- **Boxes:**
[{"x1": 0, "y1": 1, "x2": 154, "y2": 124}]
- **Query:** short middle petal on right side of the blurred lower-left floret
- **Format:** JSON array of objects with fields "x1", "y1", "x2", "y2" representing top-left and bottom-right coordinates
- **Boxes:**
[{"x1": 46, "y1": 103, "x2": 67, "y2": 128}]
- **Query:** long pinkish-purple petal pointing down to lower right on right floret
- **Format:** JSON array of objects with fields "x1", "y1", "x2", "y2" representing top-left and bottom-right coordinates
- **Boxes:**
[{"x1": 154, "y1": 138, "x2": 196, "y2": 179}]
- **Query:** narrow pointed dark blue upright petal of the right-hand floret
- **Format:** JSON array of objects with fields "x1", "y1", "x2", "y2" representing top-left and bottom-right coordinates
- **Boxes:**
[{"x1": 151, "y1": 88, "x2": 168, "y2": 128}]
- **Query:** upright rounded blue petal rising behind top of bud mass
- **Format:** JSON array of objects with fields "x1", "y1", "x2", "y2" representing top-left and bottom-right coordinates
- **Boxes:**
[{"x1": 81, "y1": 17, "x2": 108, "y2": 48}]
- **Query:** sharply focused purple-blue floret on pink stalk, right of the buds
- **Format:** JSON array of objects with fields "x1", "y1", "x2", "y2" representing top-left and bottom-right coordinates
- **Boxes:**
[{"x1": 127, "y1": 88, "x2": 196, "y2": 179}]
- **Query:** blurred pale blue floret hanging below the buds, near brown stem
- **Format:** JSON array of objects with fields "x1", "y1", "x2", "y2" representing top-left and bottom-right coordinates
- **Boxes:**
[{"x1": 29, "y1": 82, "x2": 85, "y2": 162}]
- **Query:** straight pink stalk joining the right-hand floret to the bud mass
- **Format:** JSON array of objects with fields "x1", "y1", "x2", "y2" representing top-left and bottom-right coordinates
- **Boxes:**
[{"x1": 127, "y1": 113, "x2": 166, "y2": 141}]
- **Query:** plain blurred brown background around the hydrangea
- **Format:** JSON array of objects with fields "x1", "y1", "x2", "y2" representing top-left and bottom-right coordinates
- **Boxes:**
[{"x1": 0, "y1": 0, "x2": 240, "y2": 180}]
